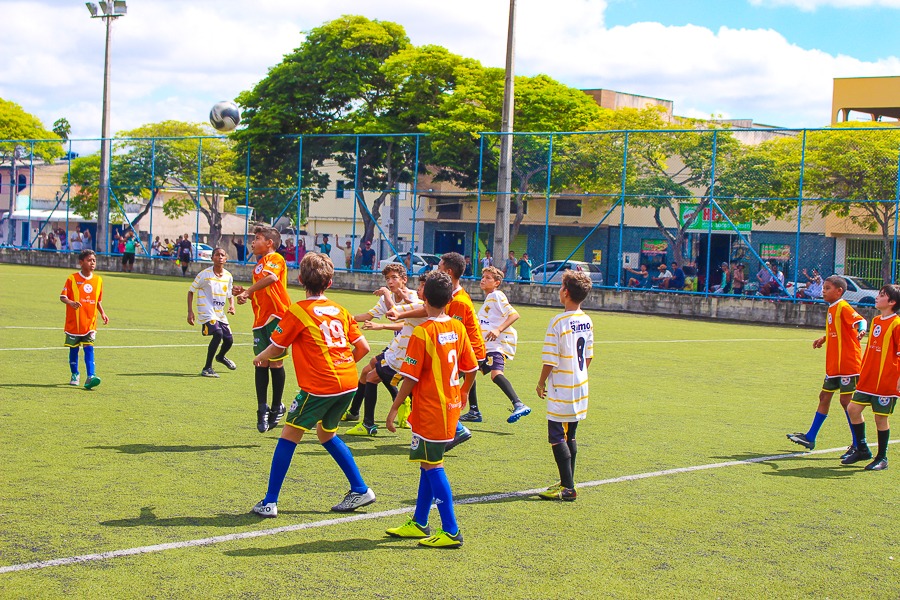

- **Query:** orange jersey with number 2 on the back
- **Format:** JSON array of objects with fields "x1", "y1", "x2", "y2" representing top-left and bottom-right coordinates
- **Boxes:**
[{"x1": 400, "y1": 315, "x2": 478, "y2": 442}]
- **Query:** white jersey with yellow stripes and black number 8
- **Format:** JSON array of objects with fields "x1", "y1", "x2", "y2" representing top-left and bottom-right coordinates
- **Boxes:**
[{"x1": 541, "y1": 310, "x2": 594, "y2": 422}]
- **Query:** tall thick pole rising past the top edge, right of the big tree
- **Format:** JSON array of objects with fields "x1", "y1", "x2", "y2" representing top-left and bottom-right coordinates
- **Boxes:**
[{"x1": 496, "y1": 0, "x2": 516, "y2": 264}]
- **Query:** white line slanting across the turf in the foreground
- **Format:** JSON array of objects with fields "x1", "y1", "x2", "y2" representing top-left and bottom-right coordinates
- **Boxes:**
[{"x1": 0, "y1": 440, "x2": 888, "y2": 574}]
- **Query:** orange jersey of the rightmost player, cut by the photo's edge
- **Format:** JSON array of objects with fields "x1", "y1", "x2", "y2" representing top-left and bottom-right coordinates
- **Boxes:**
[{"x1": 856, "y1": 315, "x2": 900, "y2": 396}]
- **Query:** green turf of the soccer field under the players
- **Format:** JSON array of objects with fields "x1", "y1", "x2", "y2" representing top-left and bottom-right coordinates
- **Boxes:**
[{"x1": 0, "y1": 265, "x2": 900, "y2": 598}]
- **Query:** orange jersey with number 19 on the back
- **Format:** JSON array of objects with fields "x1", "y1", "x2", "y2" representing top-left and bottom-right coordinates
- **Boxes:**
[{"x1": 270, "y1": 296, "x2": 362, "y2": 396}]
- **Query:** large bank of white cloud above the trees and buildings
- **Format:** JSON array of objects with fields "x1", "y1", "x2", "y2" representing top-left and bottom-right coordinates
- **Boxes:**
[{"x1": 0, "y1": 0, "x2": 900, "y2": 137}]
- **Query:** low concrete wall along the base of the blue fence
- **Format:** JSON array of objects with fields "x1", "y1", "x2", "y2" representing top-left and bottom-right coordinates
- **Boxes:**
[{"x1": 0, "y1": 248, "x2": 875, "y2": 328}]
